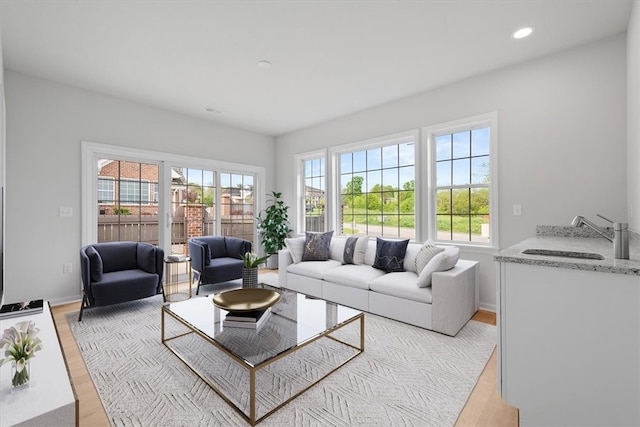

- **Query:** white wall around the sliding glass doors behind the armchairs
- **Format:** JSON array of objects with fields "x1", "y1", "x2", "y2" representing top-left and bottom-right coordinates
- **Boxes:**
[{"x1": 5, "y1": 70, "x2": 275, "y2": 303}]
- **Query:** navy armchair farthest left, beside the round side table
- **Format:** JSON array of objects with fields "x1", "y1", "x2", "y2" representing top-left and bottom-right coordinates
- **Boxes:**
[{"x1": 78, "y1": 242, "x2": 164, "y2": 321}]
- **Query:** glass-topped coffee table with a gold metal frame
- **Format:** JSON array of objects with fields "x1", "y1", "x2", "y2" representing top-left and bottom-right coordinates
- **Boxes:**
[{"x1": 161, "y1": 285, "x2": 364, "y2": 425}]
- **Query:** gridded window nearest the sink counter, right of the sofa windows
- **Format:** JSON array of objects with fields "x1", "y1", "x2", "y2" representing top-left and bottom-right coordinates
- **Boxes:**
[{"x1": 426, "y1": 114, "x2": 497, "y2": 245}]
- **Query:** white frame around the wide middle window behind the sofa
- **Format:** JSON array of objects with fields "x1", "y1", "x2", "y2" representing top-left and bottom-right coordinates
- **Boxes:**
[{"x1": 327, "y1": 129, "x2": 426, "y2": 241}]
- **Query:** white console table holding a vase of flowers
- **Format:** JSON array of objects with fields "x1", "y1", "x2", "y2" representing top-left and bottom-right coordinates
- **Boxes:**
[{"x1": 0, "y1": 302, "x2": 78, "y2": 427}]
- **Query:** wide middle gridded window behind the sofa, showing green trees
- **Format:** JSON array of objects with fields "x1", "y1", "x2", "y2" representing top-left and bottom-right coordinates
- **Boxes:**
[{"x1": 338, "y1": 133, "x2": 416, "y2": 239}]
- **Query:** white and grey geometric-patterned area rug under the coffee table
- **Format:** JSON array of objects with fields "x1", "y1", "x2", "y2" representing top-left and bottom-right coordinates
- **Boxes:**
[{"x1": 67, "y1": 273, "x2": 496, "y2": 427}]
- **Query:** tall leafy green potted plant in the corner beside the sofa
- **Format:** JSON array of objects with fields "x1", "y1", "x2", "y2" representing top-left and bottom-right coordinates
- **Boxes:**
[{"x1": 257, "y1": 191, "x2": 292, "y2": 268}]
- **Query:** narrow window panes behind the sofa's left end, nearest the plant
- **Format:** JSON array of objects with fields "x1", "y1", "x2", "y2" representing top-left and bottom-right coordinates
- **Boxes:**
[{"x1": 303, "y1": 157, "x2": 326, "y2": 231}]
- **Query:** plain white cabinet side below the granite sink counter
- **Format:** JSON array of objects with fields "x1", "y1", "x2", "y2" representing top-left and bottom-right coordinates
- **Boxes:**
[{"x1": 497, "y1": 262, "x2": 640, "y2": 426}]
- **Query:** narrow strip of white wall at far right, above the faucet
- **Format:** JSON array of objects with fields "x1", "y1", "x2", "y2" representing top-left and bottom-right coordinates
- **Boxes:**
[{"x1": 627, "y1": 0, "x2": 640, "y2": 232}]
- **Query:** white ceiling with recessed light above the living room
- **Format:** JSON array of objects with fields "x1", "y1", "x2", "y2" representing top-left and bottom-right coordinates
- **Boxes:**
[{"x1": 0, "y1": 0, "x2": 632, "y2": 135}]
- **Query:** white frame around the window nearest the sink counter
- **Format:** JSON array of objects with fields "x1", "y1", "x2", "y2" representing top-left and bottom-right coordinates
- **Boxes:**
[{"x1": 416, "y1": 112, "x2": 500, "y2": 249}]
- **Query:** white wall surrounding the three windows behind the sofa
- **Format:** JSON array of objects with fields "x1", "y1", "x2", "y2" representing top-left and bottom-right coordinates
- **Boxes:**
[{"x1": 276, "y1": 35, "x2": 627, "y2": 309}]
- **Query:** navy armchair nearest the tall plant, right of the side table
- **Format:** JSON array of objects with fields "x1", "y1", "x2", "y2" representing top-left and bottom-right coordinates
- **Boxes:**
[{"x1": 188, "y1": 236, "x2": 251, "y2": 295}]
